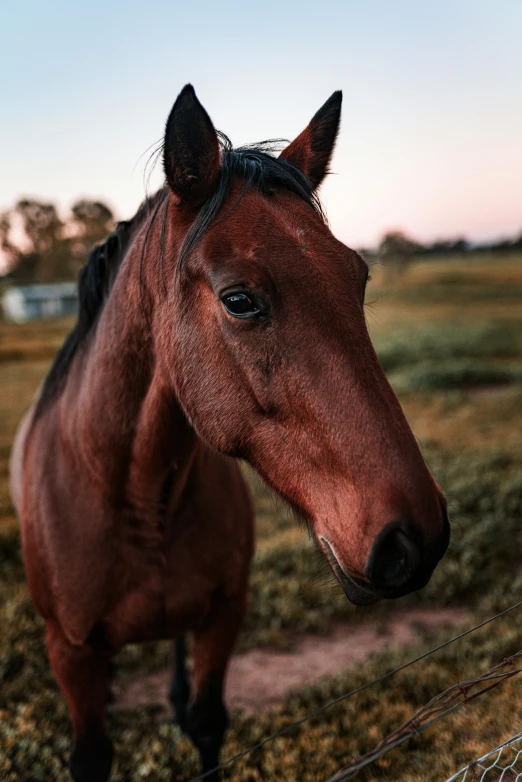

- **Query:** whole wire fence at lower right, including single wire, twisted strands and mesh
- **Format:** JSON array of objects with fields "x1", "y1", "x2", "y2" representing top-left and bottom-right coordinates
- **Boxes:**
[{"x1": 190, "y1": 600, "x2": 522, "y2": 782}]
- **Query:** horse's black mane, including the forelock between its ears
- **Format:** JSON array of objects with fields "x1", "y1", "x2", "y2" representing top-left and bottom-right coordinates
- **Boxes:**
[{"x1": 33, "y1": 141, "x2": 325, "y2": 421}]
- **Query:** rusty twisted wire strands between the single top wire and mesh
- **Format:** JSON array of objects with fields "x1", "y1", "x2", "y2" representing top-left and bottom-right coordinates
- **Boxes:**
[{"x1": 327, "y1": 650, "x2": 522, "y2": 782}]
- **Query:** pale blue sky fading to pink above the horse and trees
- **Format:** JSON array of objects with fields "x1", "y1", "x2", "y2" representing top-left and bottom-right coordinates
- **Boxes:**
[{"x1": 0, "y1": 0, "x2": 522, "y2": 247}]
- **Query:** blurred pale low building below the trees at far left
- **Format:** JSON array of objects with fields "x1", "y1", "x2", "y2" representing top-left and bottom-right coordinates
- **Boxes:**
[{"x1": 2, "y1": 282, "x2": 78, "y2": 323}]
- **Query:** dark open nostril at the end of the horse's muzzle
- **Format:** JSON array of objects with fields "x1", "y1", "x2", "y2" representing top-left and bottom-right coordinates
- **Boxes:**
[{"x1": 366, "y1": 524, "x2": 422, "y2": 589}]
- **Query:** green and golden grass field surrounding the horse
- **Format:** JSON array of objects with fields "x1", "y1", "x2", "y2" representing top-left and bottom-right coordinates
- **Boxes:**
[{"x1": 0, "y1": 256, "x2": 522, "y2": 782}]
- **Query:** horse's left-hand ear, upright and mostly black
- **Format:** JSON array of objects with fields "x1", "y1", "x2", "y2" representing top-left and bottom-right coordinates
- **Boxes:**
[{"x1": 163, "y1": 84, "x2": 221, "y2": 204}]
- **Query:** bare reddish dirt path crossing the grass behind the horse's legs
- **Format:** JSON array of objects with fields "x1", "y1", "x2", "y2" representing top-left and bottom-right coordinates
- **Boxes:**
[{"x1": 113, "y1": 608, "x2": 466, "y2": 714}]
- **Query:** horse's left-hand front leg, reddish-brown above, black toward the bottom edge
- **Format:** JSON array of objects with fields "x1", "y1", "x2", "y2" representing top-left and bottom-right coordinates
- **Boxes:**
[{"x1": 46, "y1": 624, "x2": 113, "y2": 782}]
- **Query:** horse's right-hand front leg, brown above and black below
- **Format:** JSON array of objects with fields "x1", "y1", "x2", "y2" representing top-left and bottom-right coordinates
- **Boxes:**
[{"x1": 186, "y1": 587, "x2": 246, "y2": 782}]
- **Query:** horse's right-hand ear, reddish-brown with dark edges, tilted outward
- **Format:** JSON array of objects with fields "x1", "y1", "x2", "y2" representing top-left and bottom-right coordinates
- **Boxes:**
[{"x1": 280, "y1": 90, "x2": 343, "y2": 189}]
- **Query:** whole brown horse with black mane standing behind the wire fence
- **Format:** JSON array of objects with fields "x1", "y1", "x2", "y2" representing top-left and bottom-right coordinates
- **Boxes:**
[{"x1": 11, "y1": 86, "x2": 449, "y2": 782}]
